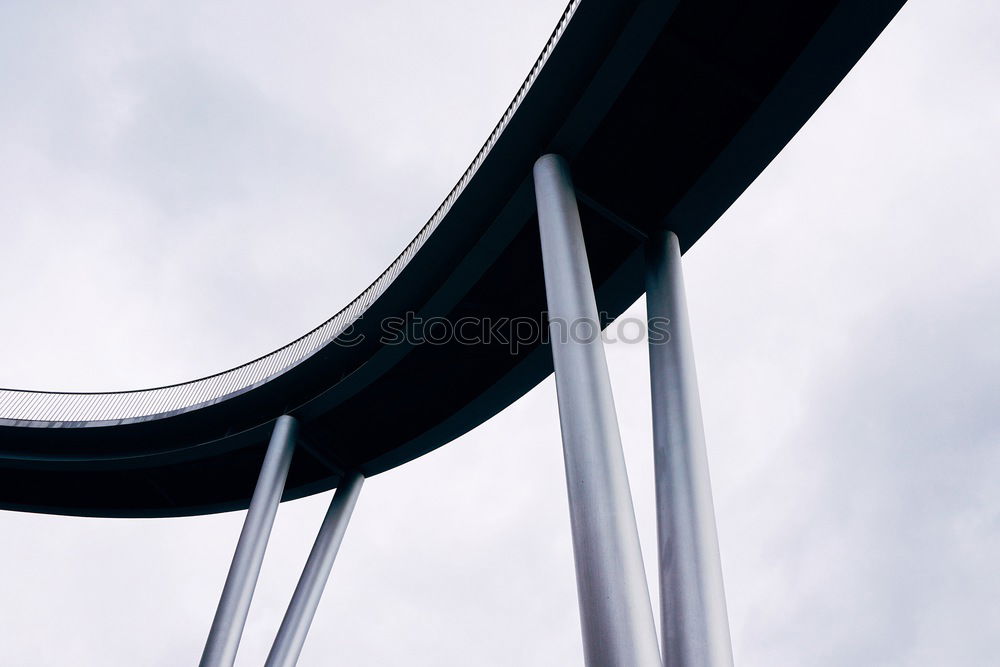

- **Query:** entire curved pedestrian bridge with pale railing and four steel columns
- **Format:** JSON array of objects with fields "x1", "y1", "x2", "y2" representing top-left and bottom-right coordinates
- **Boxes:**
[{"x1": 0, "y1": 0, "x2": 903, "y2": 667}]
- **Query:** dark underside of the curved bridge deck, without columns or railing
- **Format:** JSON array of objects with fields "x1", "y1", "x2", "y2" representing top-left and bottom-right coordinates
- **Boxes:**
[{"x1": 0, "y1": 0, "x2": 904, "y2": 516}]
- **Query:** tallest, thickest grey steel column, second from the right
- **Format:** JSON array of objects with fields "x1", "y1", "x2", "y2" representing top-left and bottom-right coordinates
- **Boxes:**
[{"x1": 534, "y1": 155, "x2": 660, "y2": 667}]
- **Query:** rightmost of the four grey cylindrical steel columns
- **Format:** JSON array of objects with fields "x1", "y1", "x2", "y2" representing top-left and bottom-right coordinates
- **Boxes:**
[{"x1": 646, "y1": 232, "x2": 733, "y2": 667}]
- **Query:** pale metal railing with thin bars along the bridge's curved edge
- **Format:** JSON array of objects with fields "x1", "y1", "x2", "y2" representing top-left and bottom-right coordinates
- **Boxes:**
[{"x1": 0, "y1": 0, "x2": 581, "y2": 426}]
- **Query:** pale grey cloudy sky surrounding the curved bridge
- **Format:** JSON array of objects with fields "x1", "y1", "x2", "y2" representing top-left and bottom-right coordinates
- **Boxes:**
[{"x1": 0, "y1": 0, "x2": 1000, "y2": 667}]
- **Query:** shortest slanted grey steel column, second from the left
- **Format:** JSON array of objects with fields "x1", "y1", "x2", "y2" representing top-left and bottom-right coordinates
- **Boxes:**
[{"x1": 265, "y1": 472, "x2": 365, "y2": 667}]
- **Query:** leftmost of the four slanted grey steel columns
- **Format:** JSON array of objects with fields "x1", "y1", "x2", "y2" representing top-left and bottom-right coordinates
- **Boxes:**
[{"x1": 200, "y1": 415, "x2": 298, "y2": 667}]
